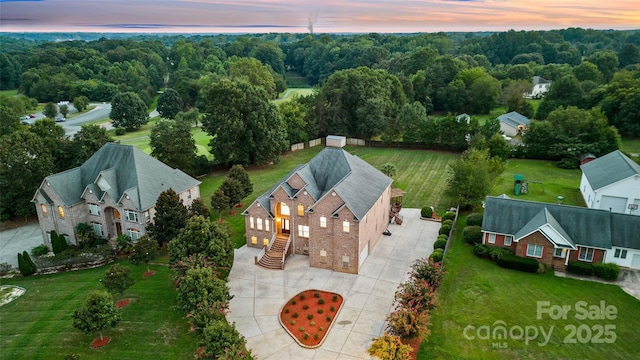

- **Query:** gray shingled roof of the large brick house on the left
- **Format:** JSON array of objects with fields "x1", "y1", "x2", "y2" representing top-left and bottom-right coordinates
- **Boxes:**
[{"x1": 45, "y1": 143, "x2": 200, "y2": 210}]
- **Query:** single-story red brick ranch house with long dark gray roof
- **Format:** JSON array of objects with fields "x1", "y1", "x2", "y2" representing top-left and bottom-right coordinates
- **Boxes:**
[{"x1": 482, "y1": 196, "x2": 640, "y2": 271}]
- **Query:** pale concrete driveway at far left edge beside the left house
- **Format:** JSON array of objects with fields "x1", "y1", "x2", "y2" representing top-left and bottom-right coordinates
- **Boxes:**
[{"x1": 0, "y1": 222, "x2": 43, "y2": 269}]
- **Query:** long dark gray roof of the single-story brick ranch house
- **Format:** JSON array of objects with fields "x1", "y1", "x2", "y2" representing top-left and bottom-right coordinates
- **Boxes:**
[{"x1": 482, "y1": 196, "x2": 640, "y2": 249}]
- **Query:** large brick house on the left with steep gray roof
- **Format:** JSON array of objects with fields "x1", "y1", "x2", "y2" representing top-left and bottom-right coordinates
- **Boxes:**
[{"x1": 31, "y1": 143, "x2": 200, "y2": 247}]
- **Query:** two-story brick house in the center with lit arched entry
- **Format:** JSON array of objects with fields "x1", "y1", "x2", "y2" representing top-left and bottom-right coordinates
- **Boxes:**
[{"x1": 243, "y1": 136, "x2": 392, "y2": 274}]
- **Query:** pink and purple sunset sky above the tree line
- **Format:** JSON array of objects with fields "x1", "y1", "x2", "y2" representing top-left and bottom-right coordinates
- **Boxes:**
[{"x1": 0, "y1": 0, "x2": 640, "y2": 33}]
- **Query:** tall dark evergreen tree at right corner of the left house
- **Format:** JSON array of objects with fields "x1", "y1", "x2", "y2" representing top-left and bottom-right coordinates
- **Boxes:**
[{"x1": 147, "y1": 189, "x2": 189, "y2": 246}]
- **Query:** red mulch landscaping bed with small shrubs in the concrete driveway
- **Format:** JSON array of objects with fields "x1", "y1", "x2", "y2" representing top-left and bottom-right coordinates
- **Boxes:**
[{"x1": 279, "y1": 290, "x2": 344, "y2": 349}]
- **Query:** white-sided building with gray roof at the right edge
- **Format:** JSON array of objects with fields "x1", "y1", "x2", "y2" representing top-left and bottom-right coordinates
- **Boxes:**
[{"x1": 580, "y1": 150, "x2": 640, "y2": 215}]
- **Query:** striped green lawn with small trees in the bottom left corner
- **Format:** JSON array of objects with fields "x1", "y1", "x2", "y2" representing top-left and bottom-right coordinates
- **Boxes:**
[{"x1": 0, "y1": 261, "x2": 197, "y2": 360}]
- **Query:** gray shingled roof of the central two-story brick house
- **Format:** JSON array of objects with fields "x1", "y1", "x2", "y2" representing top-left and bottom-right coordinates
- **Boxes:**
[{"x1": 245, "y1": 147, "x2": 392, "y2": 220}]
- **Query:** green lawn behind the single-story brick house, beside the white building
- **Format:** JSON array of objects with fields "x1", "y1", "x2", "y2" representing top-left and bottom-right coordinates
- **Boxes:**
[{"x1": 491, "y1": 159, "x2": 586, "y2": 206}]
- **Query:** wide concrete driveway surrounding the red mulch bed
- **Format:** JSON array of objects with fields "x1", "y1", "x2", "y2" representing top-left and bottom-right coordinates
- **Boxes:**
[{"x1": 227, "y1": 209, "x2": 440, "y2": 360}]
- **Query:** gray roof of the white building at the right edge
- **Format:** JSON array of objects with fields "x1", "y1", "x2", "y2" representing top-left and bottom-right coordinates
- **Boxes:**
[{"x1": 580, "y1": 150, "x2": 640, "y2": 190}]
